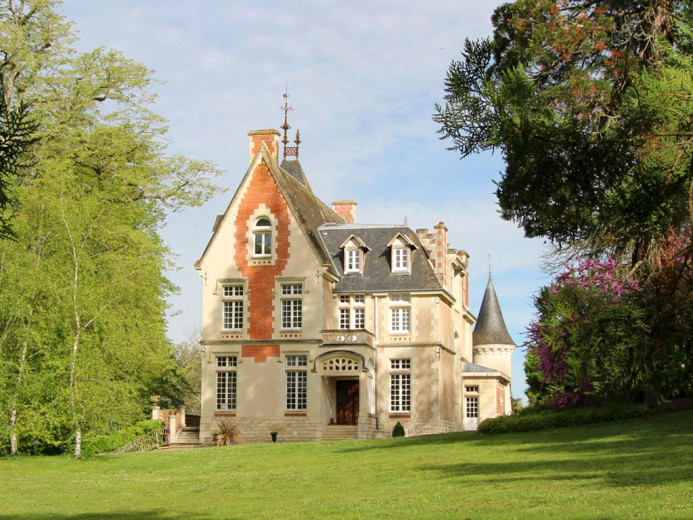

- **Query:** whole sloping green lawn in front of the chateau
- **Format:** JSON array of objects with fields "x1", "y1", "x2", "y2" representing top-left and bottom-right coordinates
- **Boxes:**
[{"x1": 0, "y1": 411, "x2": 693, "y2": 520}]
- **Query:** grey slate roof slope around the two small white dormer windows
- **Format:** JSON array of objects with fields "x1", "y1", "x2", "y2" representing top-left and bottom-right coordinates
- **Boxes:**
[{"x1": 318, "y1": 224, "x2": 442, "y2": 294}]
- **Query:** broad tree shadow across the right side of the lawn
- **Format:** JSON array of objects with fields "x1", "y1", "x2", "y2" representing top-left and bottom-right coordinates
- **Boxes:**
[{"x1": 344, "y1": 412, "x2": 693, "y2": 486}]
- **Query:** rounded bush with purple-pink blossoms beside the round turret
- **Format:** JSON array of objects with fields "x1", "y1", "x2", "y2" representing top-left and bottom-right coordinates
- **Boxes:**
[{"x1": 525, "y1": 258, "x2": 647, "y2": 408}]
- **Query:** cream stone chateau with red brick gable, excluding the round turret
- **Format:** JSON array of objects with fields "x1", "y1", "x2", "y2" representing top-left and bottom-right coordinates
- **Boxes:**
[{"x1": 195, "y1": 130, "x2": 512, "y2": 444}]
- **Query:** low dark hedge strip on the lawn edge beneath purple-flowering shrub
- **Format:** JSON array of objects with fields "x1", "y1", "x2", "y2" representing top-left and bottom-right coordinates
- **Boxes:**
[{"x1": 479, "y1": 405, "x2": 655, "y2": 433}]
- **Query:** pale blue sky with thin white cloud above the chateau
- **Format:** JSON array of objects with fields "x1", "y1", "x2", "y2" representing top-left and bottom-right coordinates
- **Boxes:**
[{"x1": 60, "y1": 0, "x2": 550, "y2": 397}]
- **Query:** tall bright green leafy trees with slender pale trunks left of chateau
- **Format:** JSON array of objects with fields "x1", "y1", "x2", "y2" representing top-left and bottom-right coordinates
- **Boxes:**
[{"x1": 0, "y1": 0, "x2": 222, "y2": 457}]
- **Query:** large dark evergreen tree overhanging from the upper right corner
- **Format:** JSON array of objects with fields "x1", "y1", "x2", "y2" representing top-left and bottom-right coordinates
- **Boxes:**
[{"x1": 434, "y1": 0, "x2": 693, "y2": 262}]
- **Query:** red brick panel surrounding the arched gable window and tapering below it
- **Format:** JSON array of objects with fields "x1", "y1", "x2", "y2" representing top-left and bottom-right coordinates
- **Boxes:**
[{"x1": 234, "y1": 163, "x2": 289, "y2": 342}]
